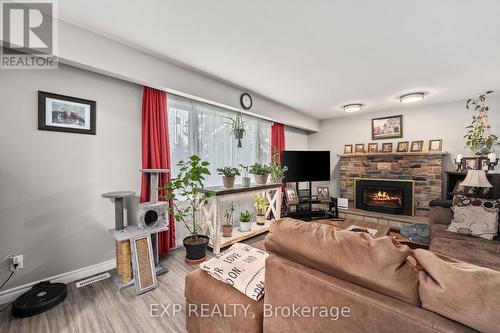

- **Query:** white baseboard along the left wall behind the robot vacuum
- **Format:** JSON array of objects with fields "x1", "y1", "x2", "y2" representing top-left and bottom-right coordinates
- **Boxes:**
[{"x1": 0, "y1": 259, "x2": 116, "y2": 304}]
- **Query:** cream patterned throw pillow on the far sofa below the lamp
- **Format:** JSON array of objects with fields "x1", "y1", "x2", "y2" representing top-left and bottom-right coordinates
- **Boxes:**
[{"x1": 448, "y1": 196, "x2": 499, "y2": 240}]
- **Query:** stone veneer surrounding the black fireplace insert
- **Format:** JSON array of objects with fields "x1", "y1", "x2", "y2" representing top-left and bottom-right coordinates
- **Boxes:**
[{"x1": 340, "y1": 153, "x2": 444, "y2": 216}]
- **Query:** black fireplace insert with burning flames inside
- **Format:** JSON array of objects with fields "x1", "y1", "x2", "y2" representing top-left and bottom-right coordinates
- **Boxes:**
[{"x1": 354, "y1": 178, "x2": 415, "y2": 216}]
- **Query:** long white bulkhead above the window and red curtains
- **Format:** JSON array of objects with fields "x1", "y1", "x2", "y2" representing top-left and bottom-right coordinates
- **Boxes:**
[{"x1": 59, "y1": 22, "x2": 319, "y2": 131}]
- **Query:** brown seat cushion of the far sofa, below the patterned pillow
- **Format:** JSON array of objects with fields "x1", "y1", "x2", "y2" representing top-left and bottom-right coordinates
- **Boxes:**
[{"x1": 429, "y1": 224, "x2": 500, "y2": 271}]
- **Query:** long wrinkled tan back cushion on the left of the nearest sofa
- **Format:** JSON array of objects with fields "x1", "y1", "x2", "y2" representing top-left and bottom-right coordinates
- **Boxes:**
[{"x1": 265, "y1": 219, "x2": 419, "y2": 305}]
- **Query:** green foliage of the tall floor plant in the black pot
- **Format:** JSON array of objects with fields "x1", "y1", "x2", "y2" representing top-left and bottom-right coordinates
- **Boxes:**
[{"x1": 160, "y1": 155, "x2": 215, "y2": 239}]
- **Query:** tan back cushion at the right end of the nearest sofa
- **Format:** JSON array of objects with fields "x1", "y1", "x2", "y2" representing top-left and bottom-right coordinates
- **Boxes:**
[{"x1": 414, "y1": 249, "x2": 500, "y2": 332}]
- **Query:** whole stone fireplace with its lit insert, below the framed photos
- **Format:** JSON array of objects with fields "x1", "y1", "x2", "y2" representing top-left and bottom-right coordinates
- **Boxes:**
[{"x1": 339, "y1": 152, "x2": 446, "y2": 216}]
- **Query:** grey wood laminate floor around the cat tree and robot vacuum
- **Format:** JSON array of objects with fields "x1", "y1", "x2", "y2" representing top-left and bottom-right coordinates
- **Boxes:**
[{"x1": 0, "y1": 234, "x2": 265, "y2": 333}]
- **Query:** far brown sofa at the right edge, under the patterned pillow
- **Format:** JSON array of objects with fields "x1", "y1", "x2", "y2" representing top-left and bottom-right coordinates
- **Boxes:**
[{"x1": 429, "y1": 200, "x2": 500, "y2": 271}]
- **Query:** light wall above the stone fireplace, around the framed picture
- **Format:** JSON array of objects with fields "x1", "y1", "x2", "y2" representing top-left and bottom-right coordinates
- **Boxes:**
[{"x1": 308, "y1": 96, "x2": 500, "y2": 195}]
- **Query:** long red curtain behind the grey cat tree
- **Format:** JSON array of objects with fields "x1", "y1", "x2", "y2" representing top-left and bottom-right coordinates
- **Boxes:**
[{"x1": 141, "y1": 87, "x2": 175, "y2": 255}]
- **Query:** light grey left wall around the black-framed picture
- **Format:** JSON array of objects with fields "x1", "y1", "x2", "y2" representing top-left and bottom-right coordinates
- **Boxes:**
[{"x1": 0, "y1": 65, "x2": 142, "y2": 289}]
